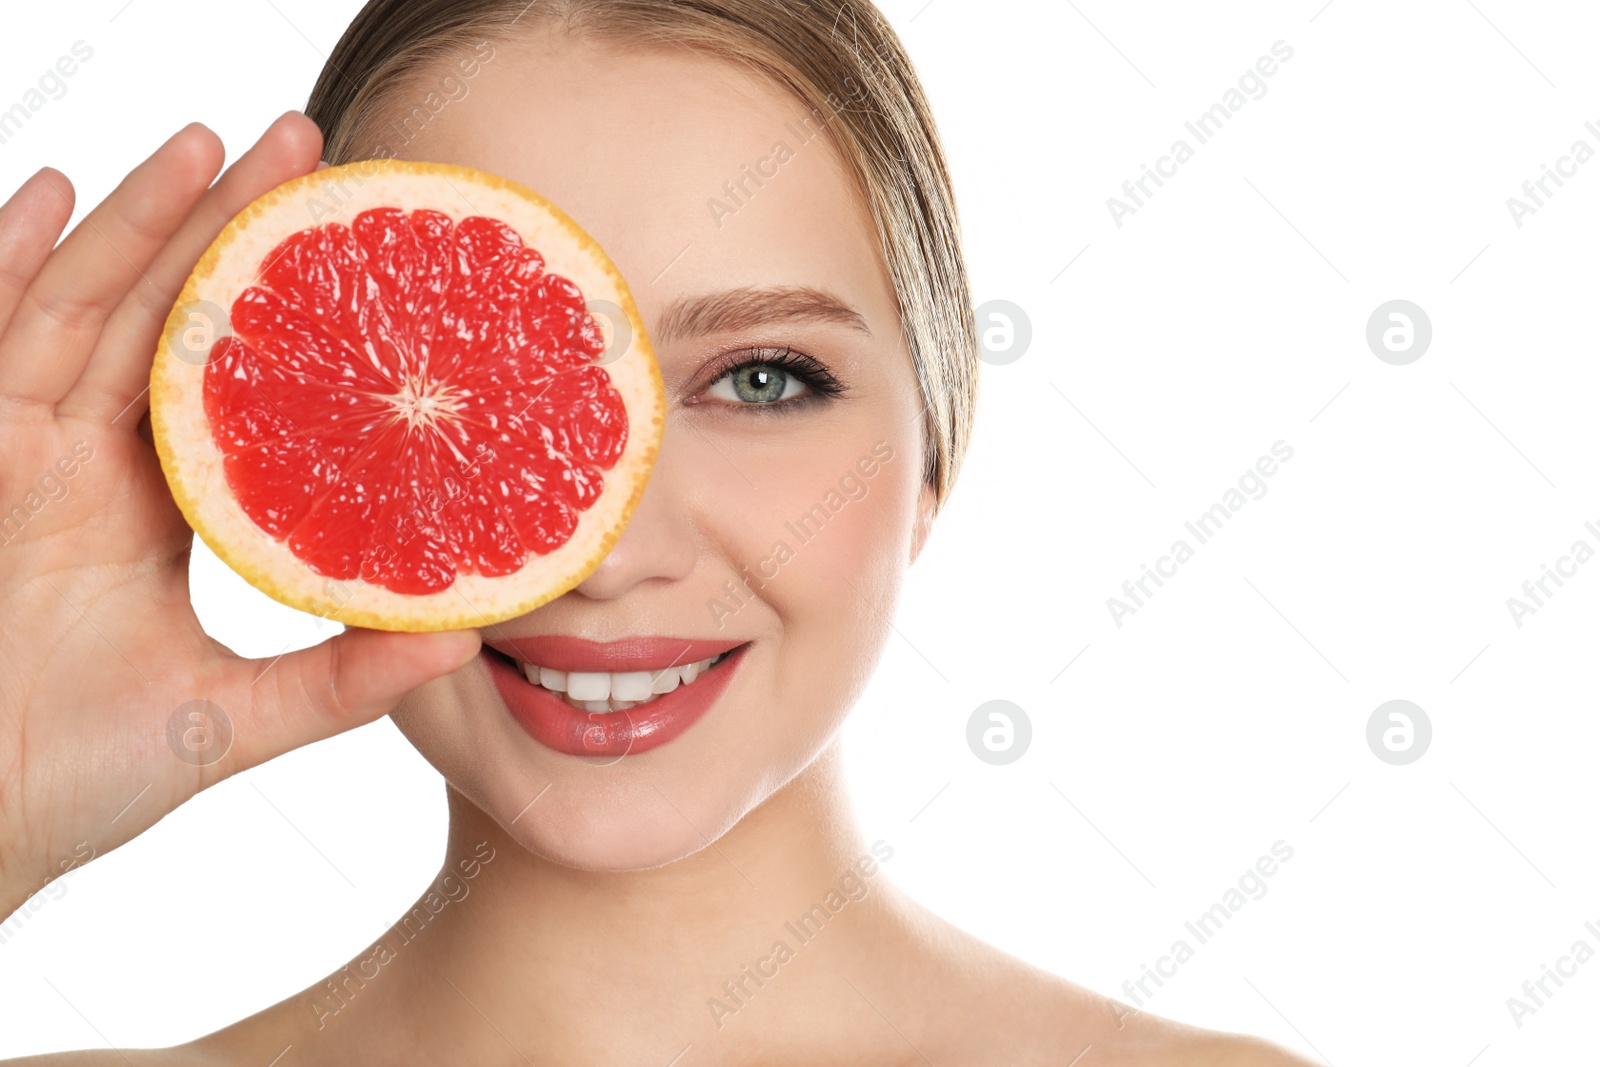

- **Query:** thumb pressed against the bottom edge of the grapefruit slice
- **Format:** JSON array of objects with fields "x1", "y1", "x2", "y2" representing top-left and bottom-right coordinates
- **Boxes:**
[{"x1": 222, "y1": 627, "x2": 482, "y2": 774}]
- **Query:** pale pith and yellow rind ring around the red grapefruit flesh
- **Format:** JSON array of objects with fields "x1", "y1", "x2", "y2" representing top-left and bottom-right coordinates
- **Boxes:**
[{"x1": 150, "y1": 160, "x2": 666, "y2": 632}]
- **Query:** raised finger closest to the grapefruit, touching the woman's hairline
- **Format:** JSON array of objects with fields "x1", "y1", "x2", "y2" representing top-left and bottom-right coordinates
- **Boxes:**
[{"x1": 58, "y1": 112, "x2": 322, "y2": 427}]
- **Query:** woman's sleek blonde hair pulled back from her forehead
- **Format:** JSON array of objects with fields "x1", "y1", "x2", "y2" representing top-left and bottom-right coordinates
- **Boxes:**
[{"x1": 306, "y1": 0, "x2": 979, "y2": 510}]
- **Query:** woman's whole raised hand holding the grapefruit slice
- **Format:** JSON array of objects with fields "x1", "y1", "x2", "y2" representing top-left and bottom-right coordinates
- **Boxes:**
[{"x1": 0, "y1": 112, "x2": 478, "y2": 920}]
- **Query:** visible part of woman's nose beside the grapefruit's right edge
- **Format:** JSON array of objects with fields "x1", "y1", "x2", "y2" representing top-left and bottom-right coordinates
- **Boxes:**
[{"x1": 574, "y1": 421, "x2": 698, "y2": 600}]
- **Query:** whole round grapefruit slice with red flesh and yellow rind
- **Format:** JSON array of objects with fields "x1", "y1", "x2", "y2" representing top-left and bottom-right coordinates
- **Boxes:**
[{"x1": 150, "y1": 160, "x2": 666, "y2": 630}]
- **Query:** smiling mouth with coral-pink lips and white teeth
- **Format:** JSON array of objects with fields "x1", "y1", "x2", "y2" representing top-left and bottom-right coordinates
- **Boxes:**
[{"x1": 483, "y1": 637, "x2": 750, "y2": 757}]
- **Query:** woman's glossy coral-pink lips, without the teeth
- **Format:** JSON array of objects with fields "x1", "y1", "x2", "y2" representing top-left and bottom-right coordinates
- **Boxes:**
[{"x1": 482, "y1": 637, "x2": 749, "y2": 757}]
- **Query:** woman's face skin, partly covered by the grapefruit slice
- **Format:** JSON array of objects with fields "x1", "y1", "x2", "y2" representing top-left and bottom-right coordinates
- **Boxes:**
[{"x1": 388, "y1": 30, "x2": 933, "y2": 870}]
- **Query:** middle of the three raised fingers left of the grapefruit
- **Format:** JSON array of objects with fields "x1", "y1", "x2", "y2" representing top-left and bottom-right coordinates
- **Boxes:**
[{"x1": 0, "y1": 123, "x2": 222, "y2": 403}]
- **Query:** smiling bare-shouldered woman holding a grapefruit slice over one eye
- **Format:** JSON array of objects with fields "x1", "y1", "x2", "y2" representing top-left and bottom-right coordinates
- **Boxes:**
[{"x1": 0, "y1": 0, "x2": 1307, "y2": 1065}]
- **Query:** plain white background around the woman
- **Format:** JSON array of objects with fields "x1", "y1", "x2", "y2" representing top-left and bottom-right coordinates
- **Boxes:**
[{"x1": 0, "y1": 0, "x2": 1600, "y2": 1067}]
